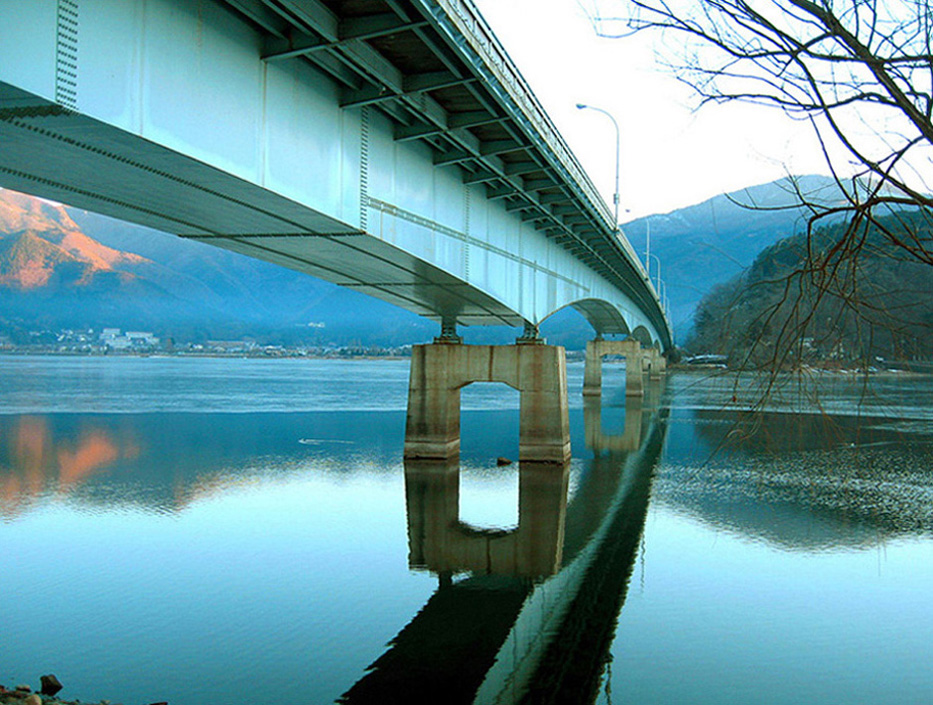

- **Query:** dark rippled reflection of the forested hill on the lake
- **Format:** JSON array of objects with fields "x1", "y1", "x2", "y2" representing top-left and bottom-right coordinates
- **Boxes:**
[{"x1": 655, "y1": 411, "x2": 933, "y2": 551}]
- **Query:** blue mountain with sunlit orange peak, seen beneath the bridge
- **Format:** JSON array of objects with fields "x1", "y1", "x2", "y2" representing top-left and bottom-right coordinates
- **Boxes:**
[{"x1": 0, "y1": 190, "x2": 436, "y2": 345}]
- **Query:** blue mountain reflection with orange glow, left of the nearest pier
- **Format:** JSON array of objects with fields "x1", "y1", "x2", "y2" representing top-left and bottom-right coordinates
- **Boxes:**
[{"x1": 0, "y1": 412, "x2": 400, "y2": 517}]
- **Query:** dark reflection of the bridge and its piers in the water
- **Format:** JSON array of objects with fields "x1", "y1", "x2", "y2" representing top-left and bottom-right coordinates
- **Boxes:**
[{"x1": 340, "y1": 390, "x2": 665, "y2": 703}]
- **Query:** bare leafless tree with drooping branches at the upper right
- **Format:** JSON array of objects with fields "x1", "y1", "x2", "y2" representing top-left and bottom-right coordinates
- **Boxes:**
[{"x1": 579, "y1": 0, "x2": 933, "y2": 372}]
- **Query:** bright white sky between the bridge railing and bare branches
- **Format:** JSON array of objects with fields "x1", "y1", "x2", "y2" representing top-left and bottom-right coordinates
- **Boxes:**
[{"x1": 474, "y1": 0, "x2": 828, "y2": 223}]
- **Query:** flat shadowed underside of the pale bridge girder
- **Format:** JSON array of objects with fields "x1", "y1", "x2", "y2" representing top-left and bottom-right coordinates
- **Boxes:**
[{"x1": 0, "y1": 83, "x2": 524, "y2": 332}]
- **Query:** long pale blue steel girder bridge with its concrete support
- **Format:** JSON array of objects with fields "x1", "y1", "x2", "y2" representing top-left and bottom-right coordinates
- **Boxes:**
[{"x1": 0, "y1": 0, "x2": 671, "y2": 462}]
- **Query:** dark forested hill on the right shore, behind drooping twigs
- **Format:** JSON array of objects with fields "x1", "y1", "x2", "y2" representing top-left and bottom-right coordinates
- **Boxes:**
[{"x1": 688, "y1": 211, "x2": 933, "y2": 367}]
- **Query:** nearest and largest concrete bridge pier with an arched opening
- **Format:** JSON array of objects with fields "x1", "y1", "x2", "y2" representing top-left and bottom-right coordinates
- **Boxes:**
[{"x1": 405, "y1": 343, "x2": 570, "y2": 463}]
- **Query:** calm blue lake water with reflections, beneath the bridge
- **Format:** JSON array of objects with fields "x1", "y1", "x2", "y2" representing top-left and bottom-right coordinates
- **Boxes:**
[{"x1": 0, "y1": 356, "x2": 933, "y2": 705}]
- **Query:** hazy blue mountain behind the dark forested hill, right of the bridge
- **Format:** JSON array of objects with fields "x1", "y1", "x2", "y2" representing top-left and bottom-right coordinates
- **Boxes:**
[{"x1": 623, "y1": 176, "x2": 839, "y2": 332}]
